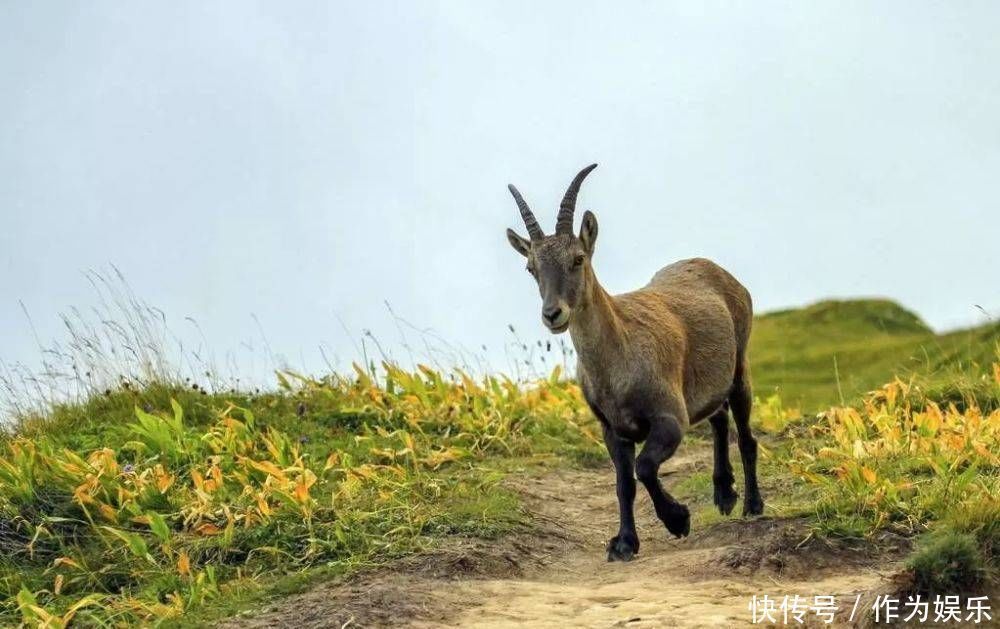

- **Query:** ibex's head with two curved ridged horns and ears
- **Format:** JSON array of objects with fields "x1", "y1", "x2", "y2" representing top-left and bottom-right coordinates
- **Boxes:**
[{"x1": 507, "y1": 164, "x2": 597, "y2": 334}]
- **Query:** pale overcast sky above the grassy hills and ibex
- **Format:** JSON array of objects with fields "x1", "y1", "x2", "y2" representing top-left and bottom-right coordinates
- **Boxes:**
[{"x1": 0, "y1": 0, "x2": 1000, "y2": 380}]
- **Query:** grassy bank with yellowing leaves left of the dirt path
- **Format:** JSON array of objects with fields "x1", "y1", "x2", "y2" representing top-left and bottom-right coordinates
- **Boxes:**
[{"x1": 0, "y1": 365, "x2": 603, "y2": 626}]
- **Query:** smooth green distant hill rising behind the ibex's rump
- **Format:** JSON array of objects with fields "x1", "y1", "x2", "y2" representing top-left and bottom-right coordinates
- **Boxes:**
[{"x1": 750, "y1": 299, "x2": 1000, "y2": 411}]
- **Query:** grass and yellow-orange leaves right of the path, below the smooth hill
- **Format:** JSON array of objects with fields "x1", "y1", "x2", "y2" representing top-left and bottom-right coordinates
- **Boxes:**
[{"x1": 776, "y1": 350, "x2": 1000, "y2": 594}]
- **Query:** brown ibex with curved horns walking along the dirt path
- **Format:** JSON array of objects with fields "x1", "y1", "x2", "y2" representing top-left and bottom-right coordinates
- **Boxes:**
[{"x1": 507, "y1": 164, "x2": 764, "y2": 561}]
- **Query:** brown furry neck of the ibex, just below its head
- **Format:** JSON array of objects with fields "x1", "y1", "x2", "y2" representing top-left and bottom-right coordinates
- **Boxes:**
[{"x1": 569, "y1": 271, "x2": 625, "y2": 378}]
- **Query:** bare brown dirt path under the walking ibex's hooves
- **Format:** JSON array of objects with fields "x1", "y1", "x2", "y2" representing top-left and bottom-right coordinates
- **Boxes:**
[{"x1": 223, "y1": 449, "x2": 898, "y2": 629}]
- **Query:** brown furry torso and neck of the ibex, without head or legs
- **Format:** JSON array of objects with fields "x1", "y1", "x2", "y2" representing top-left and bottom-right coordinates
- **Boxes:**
[{"x1": 569, "y1": 258, "x2": 752, "y2": 428}]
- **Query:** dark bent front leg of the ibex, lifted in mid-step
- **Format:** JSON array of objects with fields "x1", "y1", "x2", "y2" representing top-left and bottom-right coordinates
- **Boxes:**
[{"x1": 635, "y1": 414, "x2": 691, "y2": 537}]
